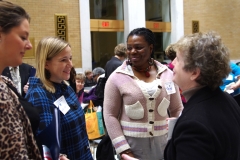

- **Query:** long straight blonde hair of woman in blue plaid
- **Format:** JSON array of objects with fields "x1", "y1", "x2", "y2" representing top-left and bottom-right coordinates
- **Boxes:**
[{"x1": 36, "y1": 37, "x2": 70, "y2": 93}]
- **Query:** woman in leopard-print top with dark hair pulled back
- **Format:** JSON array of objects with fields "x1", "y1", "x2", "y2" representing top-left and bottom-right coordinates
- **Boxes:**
[{"x1": 0, "y1": 1, "x2": 41, "y2": 160}]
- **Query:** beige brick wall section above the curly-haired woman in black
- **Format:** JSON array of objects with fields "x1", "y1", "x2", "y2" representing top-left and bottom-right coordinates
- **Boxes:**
[{"x1": 184, "y1": 0, "x2": 240, "y2": 59}]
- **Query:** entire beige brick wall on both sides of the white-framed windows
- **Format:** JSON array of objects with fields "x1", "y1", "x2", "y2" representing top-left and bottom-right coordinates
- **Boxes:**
[{"x1": 9, "y1": 0, "x2": 240, "y2": 68}]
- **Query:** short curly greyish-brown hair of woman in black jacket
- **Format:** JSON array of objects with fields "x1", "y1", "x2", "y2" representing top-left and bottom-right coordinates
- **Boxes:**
[{"x1": 174, "y1": 31, "x2": 231, "y2": 89}]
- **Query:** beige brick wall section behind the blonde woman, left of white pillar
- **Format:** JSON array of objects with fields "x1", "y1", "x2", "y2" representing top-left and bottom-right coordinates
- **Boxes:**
[{"x1": 9, "y1": 0, "x2": 82, "y2": 68}]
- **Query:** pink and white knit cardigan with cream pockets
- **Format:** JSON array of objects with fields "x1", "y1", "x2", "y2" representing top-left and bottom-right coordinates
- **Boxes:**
[{"x1": 103, "y1": 61, "x2": 183, "y2": 153}]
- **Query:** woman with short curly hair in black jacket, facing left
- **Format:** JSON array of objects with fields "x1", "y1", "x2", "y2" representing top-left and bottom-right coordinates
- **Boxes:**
[{"x1": 164, "y1": 32, "x2": 240, "y2": 160}]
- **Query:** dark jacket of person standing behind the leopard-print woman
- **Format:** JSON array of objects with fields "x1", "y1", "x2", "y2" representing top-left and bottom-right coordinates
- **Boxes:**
[{"x1": 2, "y1": 63, "x2": 34, "y2": 97}]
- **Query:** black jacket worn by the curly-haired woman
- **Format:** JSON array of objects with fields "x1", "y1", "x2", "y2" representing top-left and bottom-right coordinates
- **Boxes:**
[{"x1": 164, "y1": 87, "x2": 240, "y2": 160}]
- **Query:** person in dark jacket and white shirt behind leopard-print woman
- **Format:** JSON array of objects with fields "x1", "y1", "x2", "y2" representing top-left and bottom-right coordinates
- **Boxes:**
[{"x1": 2, "y1": 63, "x2": 36, "y2": 97}]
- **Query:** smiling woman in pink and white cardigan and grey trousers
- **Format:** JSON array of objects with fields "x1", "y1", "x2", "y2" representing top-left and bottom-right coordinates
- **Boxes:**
[{"x1": 103, "y1": 28, "x2": 183, "y2": 160}]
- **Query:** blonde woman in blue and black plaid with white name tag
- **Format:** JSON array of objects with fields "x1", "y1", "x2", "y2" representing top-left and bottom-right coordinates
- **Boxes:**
[{"x1": 26, "y1": 37, "x2": 93, "y2": 160}]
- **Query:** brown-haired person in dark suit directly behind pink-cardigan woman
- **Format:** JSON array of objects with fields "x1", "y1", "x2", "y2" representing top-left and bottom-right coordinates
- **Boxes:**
[{"x1": 105, "y1": 43, "x2": 127, "y2": 79}]
